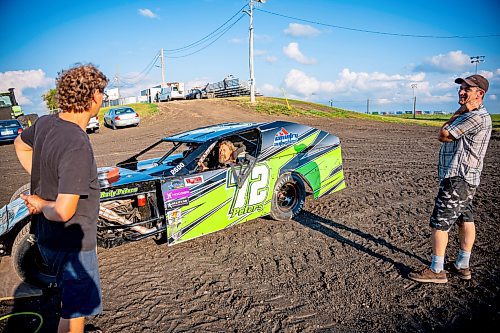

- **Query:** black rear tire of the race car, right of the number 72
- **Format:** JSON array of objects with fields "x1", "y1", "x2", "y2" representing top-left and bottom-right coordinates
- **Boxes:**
[{"x1": 270, "y1": 173, "x2": 306, "y2": 221}]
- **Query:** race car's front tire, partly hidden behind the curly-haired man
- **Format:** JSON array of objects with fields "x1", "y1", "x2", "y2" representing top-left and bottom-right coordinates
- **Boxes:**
[{"x1": 11, "y1": 223, "x2": 56, "y2": 288}]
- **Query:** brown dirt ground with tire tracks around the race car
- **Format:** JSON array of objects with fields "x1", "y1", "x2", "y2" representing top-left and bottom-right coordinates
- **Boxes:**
[{"x1": 0, "y1": 100, "x2": 500, "y2": 332}]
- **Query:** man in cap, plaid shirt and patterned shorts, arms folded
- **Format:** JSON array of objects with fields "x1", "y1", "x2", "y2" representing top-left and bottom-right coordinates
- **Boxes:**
[{"x1": 408, "y1": 74, "x2": 491, "y2": 283}]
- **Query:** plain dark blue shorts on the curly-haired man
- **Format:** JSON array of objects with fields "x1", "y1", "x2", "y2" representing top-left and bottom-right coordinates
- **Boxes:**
[{"x1": 38, "y1": 245, "x2": 102, "y2": 319}]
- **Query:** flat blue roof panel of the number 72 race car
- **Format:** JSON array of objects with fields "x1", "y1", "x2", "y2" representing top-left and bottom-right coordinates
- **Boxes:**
[{"x1": 163, "y1": 123, "x2": 263, "y2": 143}]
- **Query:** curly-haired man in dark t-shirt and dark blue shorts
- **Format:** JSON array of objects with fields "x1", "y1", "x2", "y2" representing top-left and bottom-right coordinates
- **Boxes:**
[{"x1": 15, "y1": 64, "x2": 108, "y2": 332}]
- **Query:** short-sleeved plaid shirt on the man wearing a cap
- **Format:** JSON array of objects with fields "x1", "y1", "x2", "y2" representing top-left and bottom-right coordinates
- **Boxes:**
[{"x1": 438, "y1": 105, "x2": 491, "y2": 186}]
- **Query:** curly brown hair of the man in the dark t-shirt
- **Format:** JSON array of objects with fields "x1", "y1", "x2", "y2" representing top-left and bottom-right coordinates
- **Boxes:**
[{"x1": 56, "y1": 64, "x2": 108, "y2": 112}]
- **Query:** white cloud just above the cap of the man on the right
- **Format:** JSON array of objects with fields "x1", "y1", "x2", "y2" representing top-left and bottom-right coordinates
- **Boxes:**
[{"x1": 414, "y1": 50, "x2": 472, "y2": 73}]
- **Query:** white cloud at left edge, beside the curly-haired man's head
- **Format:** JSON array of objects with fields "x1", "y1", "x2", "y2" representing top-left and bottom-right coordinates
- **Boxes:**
[{"x1": 0, "y1": 69, "x2": 55, "y2": 106}]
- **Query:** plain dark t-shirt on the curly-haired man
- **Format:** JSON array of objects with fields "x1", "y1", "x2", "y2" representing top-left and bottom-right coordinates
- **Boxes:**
[{"x1": 21, "y1": 114, "x2": 99, "y2": 251}]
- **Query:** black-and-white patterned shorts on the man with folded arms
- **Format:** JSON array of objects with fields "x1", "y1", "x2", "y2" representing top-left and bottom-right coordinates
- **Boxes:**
[{"x1": 429, "y1": 177, "x2": 477, "y2": 231}]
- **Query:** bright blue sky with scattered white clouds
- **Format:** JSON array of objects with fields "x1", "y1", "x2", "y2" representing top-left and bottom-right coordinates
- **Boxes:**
[{"x1": 0, "y1": 0, "x2": 500, "y2": 114}]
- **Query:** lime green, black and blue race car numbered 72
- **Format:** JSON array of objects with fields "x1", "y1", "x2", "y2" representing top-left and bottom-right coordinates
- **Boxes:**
[{"x1": 0, "y1": 121, "x2": 346, "y2": 285}]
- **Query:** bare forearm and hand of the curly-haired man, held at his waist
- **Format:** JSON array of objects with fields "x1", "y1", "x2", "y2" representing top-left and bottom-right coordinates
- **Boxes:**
[{"x1": 21, "y1": 194, "x2": 80, "y2": 222}]
